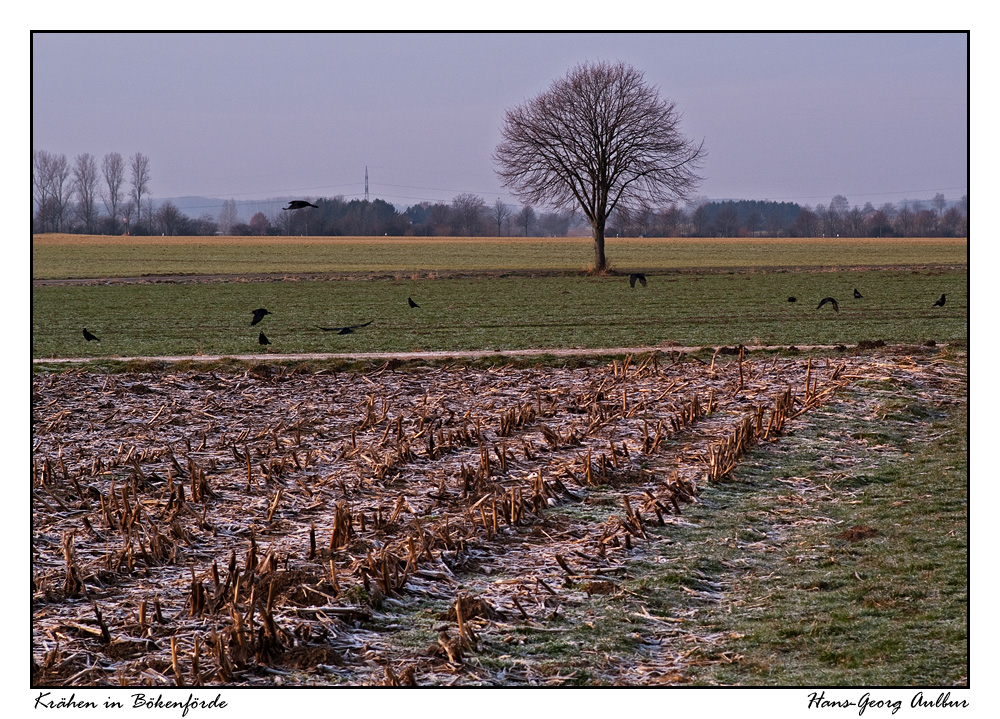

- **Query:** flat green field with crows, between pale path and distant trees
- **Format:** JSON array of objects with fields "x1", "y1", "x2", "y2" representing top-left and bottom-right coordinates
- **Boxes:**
[{"x1": 32, "y1": 238, "x2": 968, "y2": 358}]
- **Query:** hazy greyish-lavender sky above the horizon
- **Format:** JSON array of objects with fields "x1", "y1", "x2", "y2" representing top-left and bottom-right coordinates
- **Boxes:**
[{"x1": 32, "y1": 33, "x2": 969, "y2": 217}]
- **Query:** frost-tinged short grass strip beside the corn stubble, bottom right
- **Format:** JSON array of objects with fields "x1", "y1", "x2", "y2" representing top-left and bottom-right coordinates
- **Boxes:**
[{"x1": 624, "y1": 352, "x2": 969, "y2": 686}]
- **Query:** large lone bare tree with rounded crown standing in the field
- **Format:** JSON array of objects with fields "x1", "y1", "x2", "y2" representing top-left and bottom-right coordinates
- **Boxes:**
[{"x1": 494, "y1": 63, "x2": 705, "y2": 272}]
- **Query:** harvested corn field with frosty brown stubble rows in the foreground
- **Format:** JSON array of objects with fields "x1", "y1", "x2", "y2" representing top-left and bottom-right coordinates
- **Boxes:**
[{"x1": 32, "y1": 348, "x2": 952, "y2": 687}]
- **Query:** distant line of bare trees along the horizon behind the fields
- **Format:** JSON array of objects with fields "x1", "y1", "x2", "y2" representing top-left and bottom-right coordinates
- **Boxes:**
[{"x1": 31, "y1": 150, "x2": 968, "y2": 237}]
